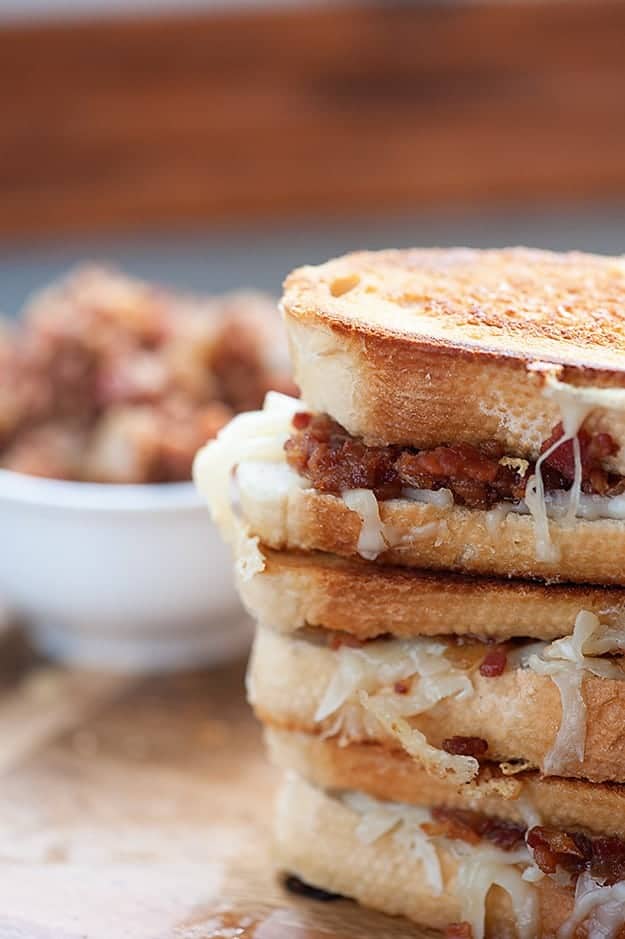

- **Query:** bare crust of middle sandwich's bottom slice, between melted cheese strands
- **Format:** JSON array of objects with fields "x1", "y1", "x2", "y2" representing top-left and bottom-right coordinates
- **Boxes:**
[{"x1": 248, "y1": 629, "x2": 625, "y2": 783}]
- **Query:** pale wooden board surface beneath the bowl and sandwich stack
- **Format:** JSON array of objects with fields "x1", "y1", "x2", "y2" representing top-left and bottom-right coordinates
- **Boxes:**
[{"x1": 0, "y1": 636, "x2": 424, "y2": 939}]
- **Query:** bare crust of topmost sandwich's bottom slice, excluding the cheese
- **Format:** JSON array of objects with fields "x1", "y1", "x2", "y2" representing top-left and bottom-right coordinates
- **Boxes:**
[{"x1": 240, "y1": 485, "x2": 625, "y2": 585}]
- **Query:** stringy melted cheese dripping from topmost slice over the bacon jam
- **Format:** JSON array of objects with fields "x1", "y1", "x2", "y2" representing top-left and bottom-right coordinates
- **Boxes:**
[{"x1": 525, "y1": 372, "x2": 625, "y2": 562}]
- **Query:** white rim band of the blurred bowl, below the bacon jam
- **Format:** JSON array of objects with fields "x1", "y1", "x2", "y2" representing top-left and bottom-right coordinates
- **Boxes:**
[{"x1": 0, "y1": 469, "x2": 204, "y2": 512}]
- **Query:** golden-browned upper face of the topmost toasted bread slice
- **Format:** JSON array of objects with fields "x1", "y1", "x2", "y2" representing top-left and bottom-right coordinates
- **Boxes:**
[{"x1": 283, "y1": 248, "x2": 625, "y2": 373}]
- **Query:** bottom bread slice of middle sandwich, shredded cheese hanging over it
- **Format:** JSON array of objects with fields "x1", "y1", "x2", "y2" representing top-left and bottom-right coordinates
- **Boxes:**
[{"x1": 248, "y1": 628, "x2": 625, "y2": 783}]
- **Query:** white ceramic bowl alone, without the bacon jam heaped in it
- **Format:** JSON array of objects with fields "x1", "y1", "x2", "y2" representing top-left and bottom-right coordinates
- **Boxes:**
[{"x1": 0, "y1": 470, "x2": 251, "y2": 671}]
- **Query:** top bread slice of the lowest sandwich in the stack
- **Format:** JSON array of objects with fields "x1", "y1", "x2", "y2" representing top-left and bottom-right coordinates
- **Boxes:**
[{"x1": 264, "y1": 725, "x2": 625, "y2": 838}]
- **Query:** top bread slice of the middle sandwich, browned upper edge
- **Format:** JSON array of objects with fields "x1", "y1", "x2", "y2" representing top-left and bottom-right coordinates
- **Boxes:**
[{"x1": 239, "y1": 548, "x2": 625, "y2": 640}]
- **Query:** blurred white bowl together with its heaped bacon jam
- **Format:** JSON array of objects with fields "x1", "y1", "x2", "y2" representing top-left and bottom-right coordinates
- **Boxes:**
[{"x1": 0, "y1": 267, "x2": 292, "y2": 669}]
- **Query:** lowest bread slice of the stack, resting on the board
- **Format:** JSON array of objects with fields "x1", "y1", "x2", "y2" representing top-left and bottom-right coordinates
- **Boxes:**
[{"x1": 275, "y1": 776, "x2": 596, "y2": 939}]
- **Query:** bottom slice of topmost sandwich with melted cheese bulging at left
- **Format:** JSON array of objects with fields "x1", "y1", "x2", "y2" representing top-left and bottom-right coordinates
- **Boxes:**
[{"x1": 194, "y1": 395, "x2": 625, "y2": 584}]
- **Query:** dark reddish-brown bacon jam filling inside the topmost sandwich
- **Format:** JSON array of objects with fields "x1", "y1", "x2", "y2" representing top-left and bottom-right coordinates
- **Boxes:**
[{"x1": 285, "y1": 412, "x2": 625, "y2": 509}]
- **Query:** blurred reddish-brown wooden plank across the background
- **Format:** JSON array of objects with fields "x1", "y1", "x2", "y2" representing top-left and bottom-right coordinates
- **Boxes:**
[{"x1": 0, "y1": 0, "x2": 625, "y2": 237}]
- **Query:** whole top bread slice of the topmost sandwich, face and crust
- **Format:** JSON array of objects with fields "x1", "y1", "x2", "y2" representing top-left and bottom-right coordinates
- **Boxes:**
[{"x1": 282, "y1": 248, "x2": 625, "y2": 473}]
